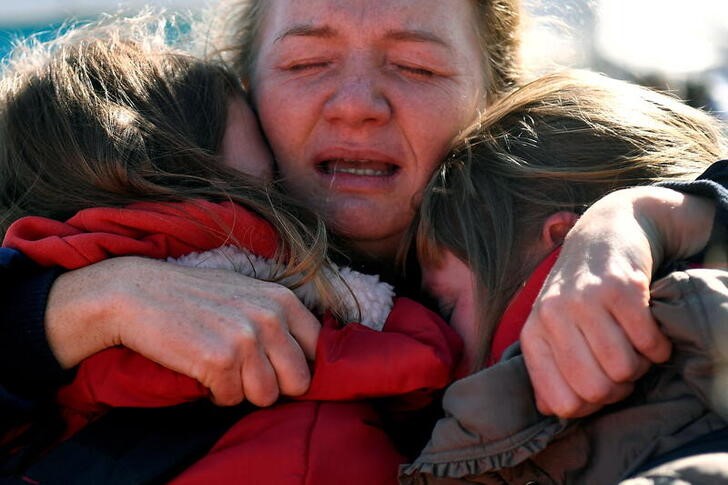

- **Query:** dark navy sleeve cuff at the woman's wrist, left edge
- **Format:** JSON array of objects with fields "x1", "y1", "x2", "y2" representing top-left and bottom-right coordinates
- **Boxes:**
[{"x1": 0, "y1": 248, "x2": 72, "y2": 397}]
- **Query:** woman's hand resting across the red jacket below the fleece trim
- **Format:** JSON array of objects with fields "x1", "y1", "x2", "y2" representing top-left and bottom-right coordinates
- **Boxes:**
[{"x1": 46, "y1": 257, "x2": 320, "y2": 406}]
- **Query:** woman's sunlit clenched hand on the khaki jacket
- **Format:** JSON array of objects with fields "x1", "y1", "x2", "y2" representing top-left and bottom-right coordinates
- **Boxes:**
[{"x1": 521, "y1": 187, "x2": 715, "y2": 417}]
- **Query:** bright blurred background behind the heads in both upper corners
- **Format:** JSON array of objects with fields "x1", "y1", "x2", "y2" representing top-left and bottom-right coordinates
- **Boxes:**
[{"x1": 0, "y1": 0, "x2": 728, "y2": 119}]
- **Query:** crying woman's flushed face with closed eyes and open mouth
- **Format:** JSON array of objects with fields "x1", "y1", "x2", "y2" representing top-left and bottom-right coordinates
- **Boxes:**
[{"x1": 252, "y1": 0, "x2": 484, "y2": 259}]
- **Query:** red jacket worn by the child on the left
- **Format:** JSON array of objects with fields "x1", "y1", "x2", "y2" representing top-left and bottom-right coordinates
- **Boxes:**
[{"x1": 5, "y1": 201, "x2": 461, "y2": 485}]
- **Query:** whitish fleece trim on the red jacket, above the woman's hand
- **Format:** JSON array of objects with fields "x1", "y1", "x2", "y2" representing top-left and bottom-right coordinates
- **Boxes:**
[{"x1": 167, "y1": 246, "x2": 394, "y2": 331}]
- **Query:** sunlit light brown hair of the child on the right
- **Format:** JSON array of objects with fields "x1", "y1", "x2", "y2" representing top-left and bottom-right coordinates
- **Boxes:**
[{"x1": 413, "y1": 71, "x2": 725, "y2": 362}]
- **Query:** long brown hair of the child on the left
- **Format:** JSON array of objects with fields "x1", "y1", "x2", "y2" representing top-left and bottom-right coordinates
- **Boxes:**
[{"x1": 0, "y1": 16, "x2": 338, "y2": 310}]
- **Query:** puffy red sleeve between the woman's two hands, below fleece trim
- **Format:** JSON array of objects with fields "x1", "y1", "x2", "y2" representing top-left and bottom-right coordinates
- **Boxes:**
[{"x1": 301, "y1": 298, "x2": 462, "y2": 400}]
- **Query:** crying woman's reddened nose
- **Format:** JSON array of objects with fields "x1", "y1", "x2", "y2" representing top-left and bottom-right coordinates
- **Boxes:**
[{"x1": 323, "y1": 66, "x2": 392, "y2": 127}]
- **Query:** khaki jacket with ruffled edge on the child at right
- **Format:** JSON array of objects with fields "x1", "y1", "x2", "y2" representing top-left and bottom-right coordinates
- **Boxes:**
[{"x1": 400, "y1": 269, "x2": 728, "y2": 485}]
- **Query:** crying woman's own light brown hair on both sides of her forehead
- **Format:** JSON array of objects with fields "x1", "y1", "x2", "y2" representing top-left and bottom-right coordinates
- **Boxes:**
[{"x1": 208, "y1": 0, "x2": 521, "y2": 99}]
